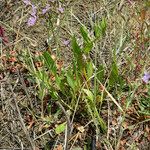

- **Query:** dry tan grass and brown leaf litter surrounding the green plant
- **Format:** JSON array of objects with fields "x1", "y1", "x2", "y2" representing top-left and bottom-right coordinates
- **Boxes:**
[{"x1": 0, "y1": 0, "x2": 150, "y2": 150}]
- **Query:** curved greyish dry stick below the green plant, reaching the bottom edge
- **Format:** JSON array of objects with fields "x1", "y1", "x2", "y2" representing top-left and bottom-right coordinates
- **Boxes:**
[{"x1": 56, "y1": 101, "x2": 71, "y2": 150}]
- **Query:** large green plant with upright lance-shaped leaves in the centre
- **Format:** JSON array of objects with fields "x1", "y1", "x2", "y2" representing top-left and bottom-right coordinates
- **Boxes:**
[{"x1": 24, "y1": 19, "x2": 109, "y2": 134}]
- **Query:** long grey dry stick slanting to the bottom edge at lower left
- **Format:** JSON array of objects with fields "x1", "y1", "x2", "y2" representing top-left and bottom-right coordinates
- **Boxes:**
[{"x1": 8, "y1": 83, "x2": 35, "y2": 150}]
